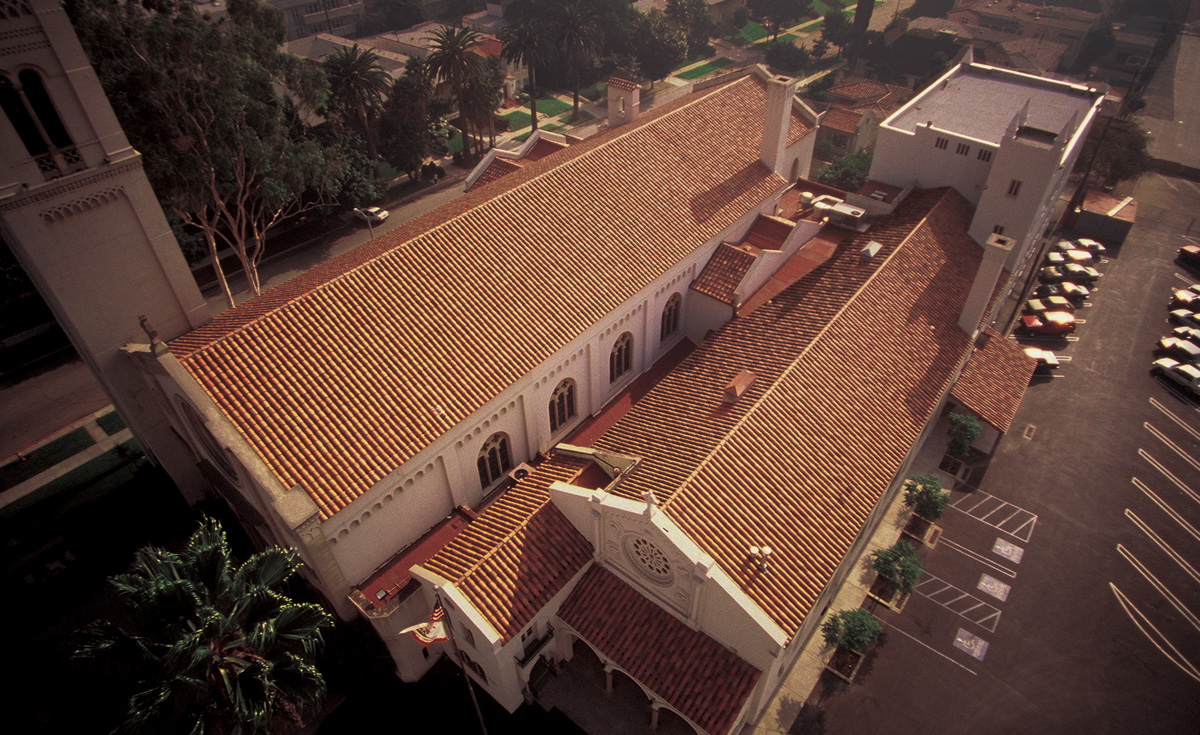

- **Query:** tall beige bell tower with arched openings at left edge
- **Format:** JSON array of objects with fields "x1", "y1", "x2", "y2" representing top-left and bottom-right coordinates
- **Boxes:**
[{"x1": 0, "y1": 0, "x2": 211, "y2": 487}]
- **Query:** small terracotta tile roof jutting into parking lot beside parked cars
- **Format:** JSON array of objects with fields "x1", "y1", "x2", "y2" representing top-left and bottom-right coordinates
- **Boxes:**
[{"x1": 950, "y1": 329, "x2": 1037, "y2": 434}]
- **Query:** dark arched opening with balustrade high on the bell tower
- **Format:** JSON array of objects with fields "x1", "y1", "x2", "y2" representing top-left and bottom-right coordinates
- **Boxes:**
[{"x1": 0, "y1": 68, "x2": 85, "y2": 179}]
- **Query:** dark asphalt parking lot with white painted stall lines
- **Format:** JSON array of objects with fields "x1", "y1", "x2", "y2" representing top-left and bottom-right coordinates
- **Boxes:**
[{"x1": 791, "y1": 174, "x2": 1200, "y2": 734}]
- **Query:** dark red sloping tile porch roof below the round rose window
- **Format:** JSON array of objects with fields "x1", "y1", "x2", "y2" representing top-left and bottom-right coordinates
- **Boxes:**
[{"x1": 558, "y1": 564, "x2": 761, "y2": 734}]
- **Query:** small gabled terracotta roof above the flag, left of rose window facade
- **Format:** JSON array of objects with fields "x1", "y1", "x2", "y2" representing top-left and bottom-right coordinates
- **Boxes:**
[{"x1": 424, "y1": 453, "x2": 594, "y2": 641}]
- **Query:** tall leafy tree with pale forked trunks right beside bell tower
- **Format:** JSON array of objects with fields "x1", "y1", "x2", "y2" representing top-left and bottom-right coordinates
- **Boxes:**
[{"x1": 68, "y1": 0, "x2": 347, "y2": 305}]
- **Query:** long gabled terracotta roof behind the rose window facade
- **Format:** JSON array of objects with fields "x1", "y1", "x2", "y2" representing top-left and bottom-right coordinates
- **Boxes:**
[{"x1": 595, "y1": 190, "x2": 982, "y2": 635}]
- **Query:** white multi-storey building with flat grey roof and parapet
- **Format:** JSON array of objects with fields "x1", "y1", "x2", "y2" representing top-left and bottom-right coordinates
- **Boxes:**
[{"x1": 871, "y1": 49, "x2": 1105, "y2": 270}]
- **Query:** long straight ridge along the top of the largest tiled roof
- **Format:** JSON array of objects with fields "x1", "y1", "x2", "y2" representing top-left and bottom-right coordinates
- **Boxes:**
[{"x1": 170, "y1": 76, "x2": 751, "y2": 357}]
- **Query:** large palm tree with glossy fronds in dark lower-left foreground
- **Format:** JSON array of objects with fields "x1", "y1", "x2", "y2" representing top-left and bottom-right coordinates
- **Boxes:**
[{"x1": 76, "y1": 519, "x2": 332, "y2": 734}]
